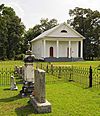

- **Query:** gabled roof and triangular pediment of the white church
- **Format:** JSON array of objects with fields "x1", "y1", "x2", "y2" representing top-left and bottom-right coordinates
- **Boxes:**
[{"x1": 31, "y1": 22, "x2": 85, "y2": 42}]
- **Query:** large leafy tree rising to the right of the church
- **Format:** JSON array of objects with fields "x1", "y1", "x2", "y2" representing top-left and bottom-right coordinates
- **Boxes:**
[{"x1": 68, "y1": 7, "x2": 100, "y2": 58}]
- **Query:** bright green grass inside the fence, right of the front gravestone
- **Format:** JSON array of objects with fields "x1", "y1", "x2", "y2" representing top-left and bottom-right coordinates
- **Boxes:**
[{"x1": 48, "y1": 83, "x2": 100, "y2": 116}]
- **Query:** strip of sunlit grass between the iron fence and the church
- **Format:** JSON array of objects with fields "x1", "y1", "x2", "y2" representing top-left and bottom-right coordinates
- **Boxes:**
[{"x1": 0, "y1": 61, "x2": 100, "y2": 68}]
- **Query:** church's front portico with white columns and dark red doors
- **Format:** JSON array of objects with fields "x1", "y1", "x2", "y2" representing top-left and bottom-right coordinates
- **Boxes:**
[{"x1": 43, "y1": 40, "x2": 83, "y2": 58}]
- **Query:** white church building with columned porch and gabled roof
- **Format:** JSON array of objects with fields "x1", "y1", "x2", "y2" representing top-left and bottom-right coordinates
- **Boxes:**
[{"x1": 31, "y1": 23, "x2": 85, "y2": 61}]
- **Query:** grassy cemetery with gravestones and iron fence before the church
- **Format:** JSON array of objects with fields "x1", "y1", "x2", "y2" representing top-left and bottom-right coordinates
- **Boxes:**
[{"x1": 0, "y1": 44, "x2": 100, "y2": 116}]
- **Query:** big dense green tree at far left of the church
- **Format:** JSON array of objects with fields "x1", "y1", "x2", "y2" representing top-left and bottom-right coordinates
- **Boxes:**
[{"x1": 0, "y1": 4, "x2": 25, "y2": 59}]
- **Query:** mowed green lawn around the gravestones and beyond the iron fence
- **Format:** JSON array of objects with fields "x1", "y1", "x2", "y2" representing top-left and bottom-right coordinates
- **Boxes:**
[{"x1": 0, "y1": 61, "x2": 100, "y2": 116}]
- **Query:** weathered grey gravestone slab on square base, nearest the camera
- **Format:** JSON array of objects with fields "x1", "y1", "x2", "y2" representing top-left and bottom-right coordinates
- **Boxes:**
[{"x1": 30, "y1": 69, "x2": 51, "y2": 113}]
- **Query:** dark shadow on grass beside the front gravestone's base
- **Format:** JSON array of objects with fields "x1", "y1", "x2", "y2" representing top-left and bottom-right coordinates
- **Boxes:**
[{"x1": 15, "y1": 104, "x2": 35, "y2": 116}]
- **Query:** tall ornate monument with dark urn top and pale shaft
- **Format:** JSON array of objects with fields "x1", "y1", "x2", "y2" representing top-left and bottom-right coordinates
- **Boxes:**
[{"x1": 20, "y1": 42, "x2": 35, "y2": 97}]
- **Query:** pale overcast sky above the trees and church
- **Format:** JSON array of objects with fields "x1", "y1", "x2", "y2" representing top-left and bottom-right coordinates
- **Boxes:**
[{"x1": 0, "y1": 0, "x2": 100, "y2": 29}]
